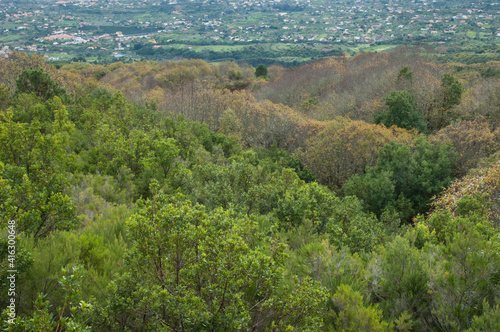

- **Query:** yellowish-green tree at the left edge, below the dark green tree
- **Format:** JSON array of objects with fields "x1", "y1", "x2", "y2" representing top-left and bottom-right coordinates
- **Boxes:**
[{"x1": 0, "y1": 107, "x2": 77, "y2": 237}]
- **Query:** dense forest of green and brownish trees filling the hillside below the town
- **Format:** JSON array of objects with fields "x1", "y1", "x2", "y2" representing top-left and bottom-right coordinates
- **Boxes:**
[{"x1": 0, "y1": 47, "x2": 500, "y2": 331}]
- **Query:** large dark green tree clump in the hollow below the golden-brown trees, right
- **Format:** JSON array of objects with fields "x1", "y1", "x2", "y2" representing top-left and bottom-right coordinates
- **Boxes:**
[{"x1": 342, "y1": 137, "x2": 457, "y2": 218}]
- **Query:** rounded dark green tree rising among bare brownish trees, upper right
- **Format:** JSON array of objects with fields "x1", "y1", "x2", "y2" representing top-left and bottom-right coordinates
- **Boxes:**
[{"x1": 375, "y1": 90, "x2": 426, "y2": 132}]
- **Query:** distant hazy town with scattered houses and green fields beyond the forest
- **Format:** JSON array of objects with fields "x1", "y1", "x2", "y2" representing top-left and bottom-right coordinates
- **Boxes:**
[{"x1": 0, "y1": 0, "x2": 500, "y2": 62}]
